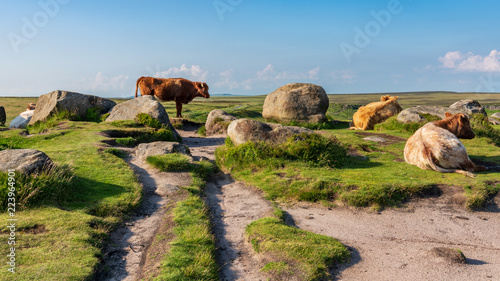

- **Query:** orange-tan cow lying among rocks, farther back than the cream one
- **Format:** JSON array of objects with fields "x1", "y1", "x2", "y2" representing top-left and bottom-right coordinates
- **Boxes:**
[{"x1": 350, "y1": 96, "x2": 403, "y2": 130}]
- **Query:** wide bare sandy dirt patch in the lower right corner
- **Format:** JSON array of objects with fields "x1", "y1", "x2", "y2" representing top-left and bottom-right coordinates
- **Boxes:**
[{"x1": 286, "y1": 187, "x2": 500, "y2": 281}]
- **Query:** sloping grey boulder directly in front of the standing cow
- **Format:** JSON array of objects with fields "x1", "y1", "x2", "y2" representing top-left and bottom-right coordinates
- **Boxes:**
[{"x1": 106, "y1": 96, "x2": 181, "y2": 140}]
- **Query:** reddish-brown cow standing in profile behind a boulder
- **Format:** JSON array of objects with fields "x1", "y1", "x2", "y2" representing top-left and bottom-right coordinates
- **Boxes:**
[{"x1": 135, "y1": 77, "x2": 210, "y2": 117}]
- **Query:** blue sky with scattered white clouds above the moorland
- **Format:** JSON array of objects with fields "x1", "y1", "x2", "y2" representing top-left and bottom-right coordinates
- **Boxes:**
[{"x1": 0, "y1": 0, "x2": 500, "y2": 97}]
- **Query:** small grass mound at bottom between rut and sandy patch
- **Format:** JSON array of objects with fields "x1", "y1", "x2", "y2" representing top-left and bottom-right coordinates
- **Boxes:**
[{"x1": 245, "y1": 213, "x2": 350, "y2": 280}]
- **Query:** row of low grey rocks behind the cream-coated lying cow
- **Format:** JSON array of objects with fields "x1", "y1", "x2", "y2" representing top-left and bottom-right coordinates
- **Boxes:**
[{"x1": 398, "y1": 100, "x2": 486, "y2": 123}]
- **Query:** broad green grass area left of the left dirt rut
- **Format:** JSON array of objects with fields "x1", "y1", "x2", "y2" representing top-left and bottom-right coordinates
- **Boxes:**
[{"x1": 0, "y1": 121, "x2": 141, "y2": 280}]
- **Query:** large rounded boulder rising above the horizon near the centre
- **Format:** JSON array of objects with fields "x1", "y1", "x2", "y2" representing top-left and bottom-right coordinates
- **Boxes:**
[{"x1": 262, "y1": 83, "x2": 329, "y2": 123}]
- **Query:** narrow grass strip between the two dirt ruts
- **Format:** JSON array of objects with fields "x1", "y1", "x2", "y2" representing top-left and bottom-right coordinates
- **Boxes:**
[{"x1": 155, "y1": 158, "x2": 219, "y2": 281}]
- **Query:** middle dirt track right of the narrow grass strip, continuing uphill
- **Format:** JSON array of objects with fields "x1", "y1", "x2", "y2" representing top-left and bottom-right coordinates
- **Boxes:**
[{"x1": 179, "y1": 128, "x2": 272, "y2": 281}]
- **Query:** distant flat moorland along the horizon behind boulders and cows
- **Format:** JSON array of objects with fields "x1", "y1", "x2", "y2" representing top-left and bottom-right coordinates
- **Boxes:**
[{"x1": 0, "y1": 92, "x2": 500, "y2": 125}]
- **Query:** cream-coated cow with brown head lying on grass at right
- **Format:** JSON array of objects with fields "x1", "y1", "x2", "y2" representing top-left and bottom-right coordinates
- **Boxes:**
[{"x1": 404, "y1": 112, "x2": 486, "y2": 177}]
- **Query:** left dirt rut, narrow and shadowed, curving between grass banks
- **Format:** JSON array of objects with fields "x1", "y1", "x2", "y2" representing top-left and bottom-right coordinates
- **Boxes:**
[{"x1": 97, "y1": 149, "x2": 191, "y2": 281}]
